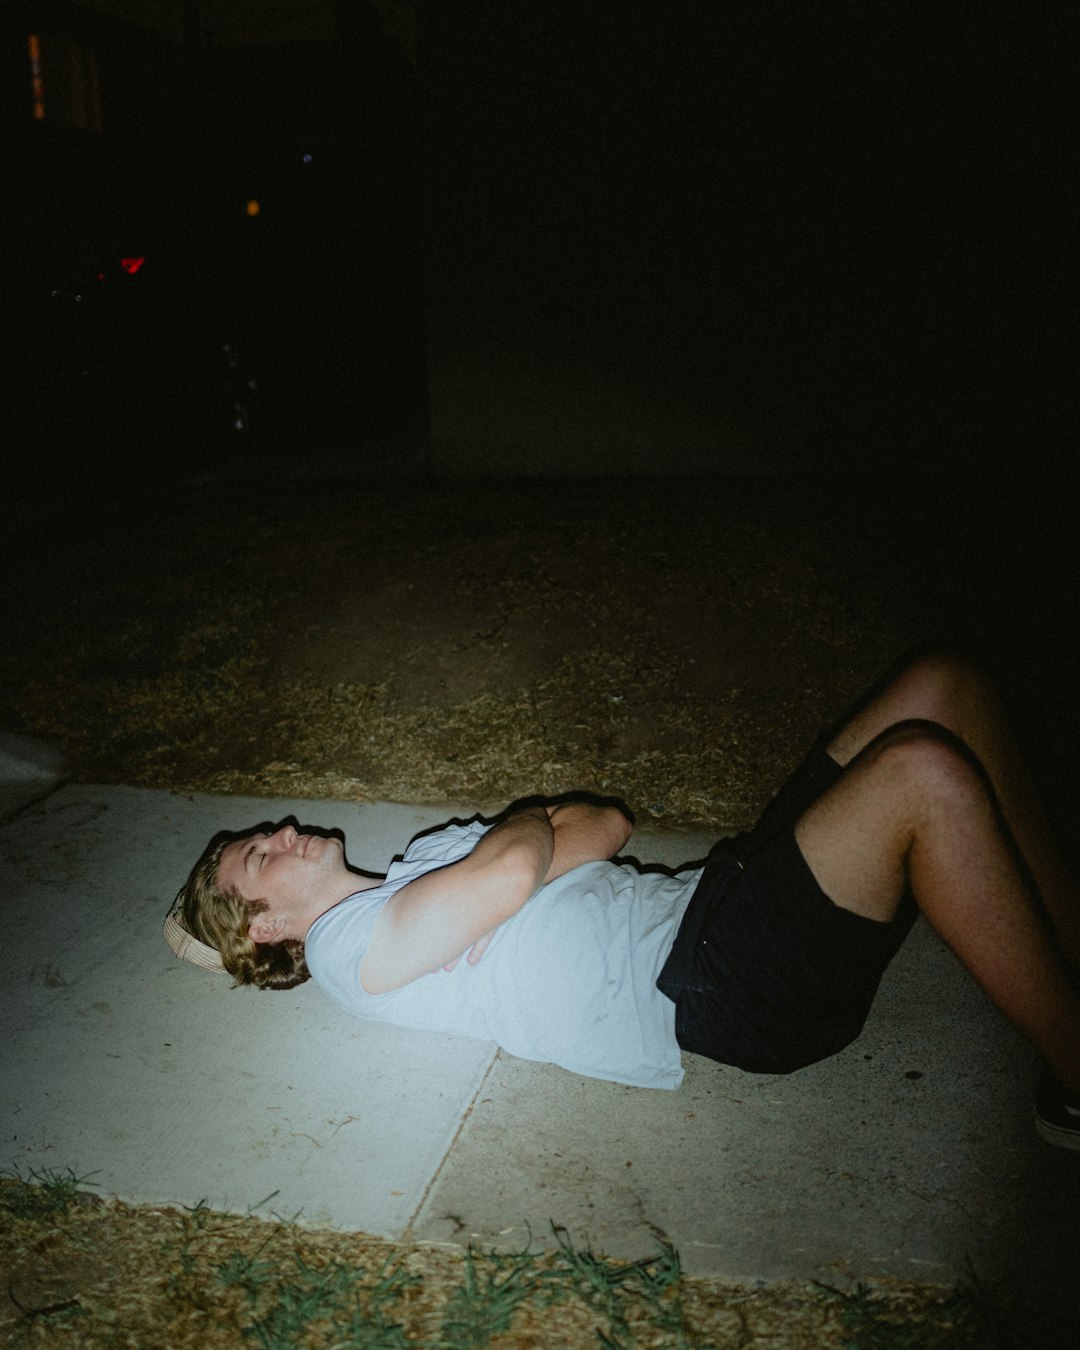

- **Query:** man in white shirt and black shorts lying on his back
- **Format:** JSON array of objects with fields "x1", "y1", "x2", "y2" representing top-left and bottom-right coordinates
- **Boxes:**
[{"x1": 170, "y1": 656, "x2": 1080, "y2": 1149}]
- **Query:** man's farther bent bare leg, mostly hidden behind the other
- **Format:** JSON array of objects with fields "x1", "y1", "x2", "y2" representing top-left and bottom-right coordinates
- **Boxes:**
[{"x1": 828, "y1": 656, "x2": 1080, "y2": 979}]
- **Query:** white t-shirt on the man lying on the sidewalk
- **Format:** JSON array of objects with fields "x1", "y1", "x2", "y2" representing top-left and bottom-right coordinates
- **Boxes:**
[{"x1": 305, "y1": 822, "x2": 701, "y2": 1088}]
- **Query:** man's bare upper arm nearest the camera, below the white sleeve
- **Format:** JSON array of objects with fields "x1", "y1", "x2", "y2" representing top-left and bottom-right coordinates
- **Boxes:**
[{"x1": 360, "y1": 806, "x2": 555, "y2": 994}]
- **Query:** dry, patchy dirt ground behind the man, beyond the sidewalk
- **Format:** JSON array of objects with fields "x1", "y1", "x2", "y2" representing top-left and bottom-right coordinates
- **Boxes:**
[{"x1": 0, "y1": 473, "x2": 1076, "y2": 826}]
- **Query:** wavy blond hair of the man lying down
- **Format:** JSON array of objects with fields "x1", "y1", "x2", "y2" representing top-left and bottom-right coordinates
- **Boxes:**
[{"x1": 178, "y1": 834, "x2": 311, "y2": 990}]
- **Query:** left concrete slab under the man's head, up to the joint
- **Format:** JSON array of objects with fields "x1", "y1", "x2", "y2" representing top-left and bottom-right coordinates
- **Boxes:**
[{"x1": 0, "y1": 786, "x2": 494, "y2": 1237}]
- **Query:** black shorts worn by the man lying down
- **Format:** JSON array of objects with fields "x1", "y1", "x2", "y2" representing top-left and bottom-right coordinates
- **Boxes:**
[{"x1": 656, "y1": 744, "x2": 918, "y2": 1073}]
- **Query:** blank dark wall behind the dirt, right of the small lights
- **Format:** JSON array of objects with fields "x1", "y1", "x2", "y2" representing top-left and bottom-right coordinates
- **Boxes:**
[{"x1": 424, "y1": 0, "x2": 1075, "y2": 474}]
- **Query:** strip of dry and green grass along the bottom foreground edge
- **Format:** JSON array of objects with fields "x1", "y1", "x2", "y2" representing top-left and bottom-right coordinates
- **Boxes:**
[{"x1": 0, "y1": 1169, "x2": 1053, "y2": 1350}]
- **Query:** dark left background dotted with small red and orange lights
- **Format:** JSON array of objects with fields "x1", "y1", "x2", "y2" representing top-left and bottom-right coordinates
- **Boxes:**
[{"x1": 4, "y1": 4, "x2": 425, "y2": 481}]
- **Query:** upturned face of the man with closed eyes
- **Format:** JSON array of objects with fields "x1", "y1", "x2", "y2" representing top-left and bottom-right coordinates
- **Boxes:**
[{"x1": 217, "y1": 825, "x2": 356, "y2": 937}]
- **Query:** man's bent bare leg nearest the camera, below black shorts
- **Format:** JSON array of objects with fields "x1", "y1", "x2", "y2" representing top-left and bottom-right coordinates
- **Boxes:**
[{"x1": 795, "y1": 714, "x2": 1080, "y2": 1092}]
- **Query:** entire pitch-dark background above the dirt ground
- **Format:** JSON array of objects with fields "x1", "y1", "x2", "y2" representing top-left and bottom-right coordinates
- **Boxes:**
[{"x1": 3, "y1": 0, "x2": 1076, "y2": 482}]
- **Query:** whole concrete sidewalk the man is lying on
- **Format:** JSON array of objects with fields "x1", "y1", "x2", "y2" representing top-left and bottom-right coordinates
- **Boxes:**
[{"x1": 0, "y1": 741, "x2": 1080, "y2": 1305}]
